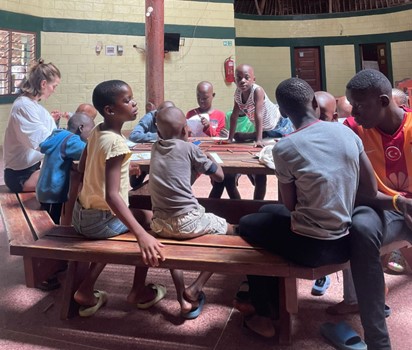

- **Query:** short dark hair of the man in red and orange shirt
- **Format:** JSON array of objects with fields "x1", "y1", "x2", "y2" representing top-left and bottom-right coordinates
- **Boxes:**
[{"x1": 346, "y1": 69, "x2": 392, "y2": 96}]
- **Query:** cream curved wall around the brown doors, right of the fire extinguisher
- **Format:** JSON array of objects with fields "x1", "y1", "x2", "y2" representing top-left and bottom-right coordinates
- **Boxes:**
[{"x1": 235, "y1": 10, "x2": 412, "y2": 96}]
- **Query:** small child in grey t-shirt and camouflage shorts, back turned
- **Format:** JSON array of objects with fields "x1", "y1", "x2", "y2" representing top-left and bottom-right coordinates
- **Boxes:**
[{"x1": 149, "y1": 107, "x2": 233, "y2": 319}]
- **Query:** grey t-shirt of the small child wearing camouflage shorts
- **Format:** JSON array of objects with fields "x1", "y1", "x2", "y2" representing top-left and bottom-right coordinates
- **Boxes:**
[{"x1": 149, "y1": 139, "x2": 214, "y2": 219}]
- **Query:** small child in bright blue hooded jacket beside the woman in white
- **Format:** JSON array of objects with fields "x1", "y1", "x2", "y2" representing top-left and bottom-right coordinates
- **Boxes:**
[{"x1": 36, "y1": 113, "x2": 94, "y2": 225}]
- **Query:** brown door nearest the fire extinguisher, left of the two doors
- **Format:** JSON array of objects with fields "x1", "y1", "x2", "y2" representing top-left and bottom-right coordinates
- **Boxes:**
[{"x1": 294, "y1": 47, "x2": 322, "y2": 91}]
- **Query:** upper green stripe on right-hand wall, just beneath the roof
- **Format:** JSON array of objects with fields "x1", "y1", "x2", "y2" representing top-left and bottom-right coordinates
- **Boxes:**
[{"x1": 235, "y1": 4, "x2": 412, "y2": 21}]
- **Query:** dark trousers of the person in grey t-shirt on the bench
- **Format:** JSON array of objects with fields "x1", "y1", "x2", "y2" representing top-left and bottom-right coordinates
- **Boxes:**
[{"x1": 239, "y1": 204, "x2": 349, "y2": 316}]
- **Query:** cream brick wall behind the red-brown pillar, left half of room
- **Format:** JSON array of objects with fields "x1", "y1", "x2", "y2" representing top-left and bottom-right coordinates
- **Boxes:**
[{"x1": 0, "y1": 0, "x2": 235, "y2": 140}]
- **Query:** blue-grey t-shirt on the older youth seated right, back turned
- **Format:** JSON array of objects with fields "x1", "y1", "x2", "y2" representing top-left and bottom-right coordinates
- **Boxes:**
[{"x1": 273, "y1": 121, "x2": 363, "y2": 239}]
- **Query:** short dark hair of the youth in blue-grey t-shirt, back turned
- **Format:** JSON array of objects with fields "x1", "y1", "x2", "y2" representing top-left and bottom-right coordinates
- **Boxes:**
[{"x1": 276, "y1": 78, "x2": 315, "y2": 114}]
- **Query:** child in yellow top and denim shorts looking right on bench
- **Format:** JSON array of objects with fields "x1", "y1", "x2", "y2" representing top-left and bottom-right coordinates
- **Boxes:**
[{"x1": 72, "y1": 80, "x2": 166, "y2": 317}]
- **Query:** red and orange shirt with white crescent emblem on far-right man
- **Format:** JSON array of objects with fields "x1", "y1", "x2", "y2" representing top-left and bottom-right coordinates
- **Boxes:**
[{"x1": 344, "y1": 112, "x2": 412, "y2": 198}]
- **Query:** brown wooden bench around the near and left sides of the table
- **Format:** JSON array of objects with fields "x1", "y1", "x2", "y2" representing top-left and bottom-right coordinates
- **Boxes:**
[{"x1": 0, "y1": 191, "x2": 406, "y2": 344}]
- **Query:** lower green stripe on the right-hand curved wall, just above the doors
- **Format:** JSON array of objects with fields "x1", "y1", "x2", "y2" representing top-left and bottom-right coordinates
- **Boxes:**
[{"x1": 235, "y1": 30, "x2": 412, "y2": 47}]
